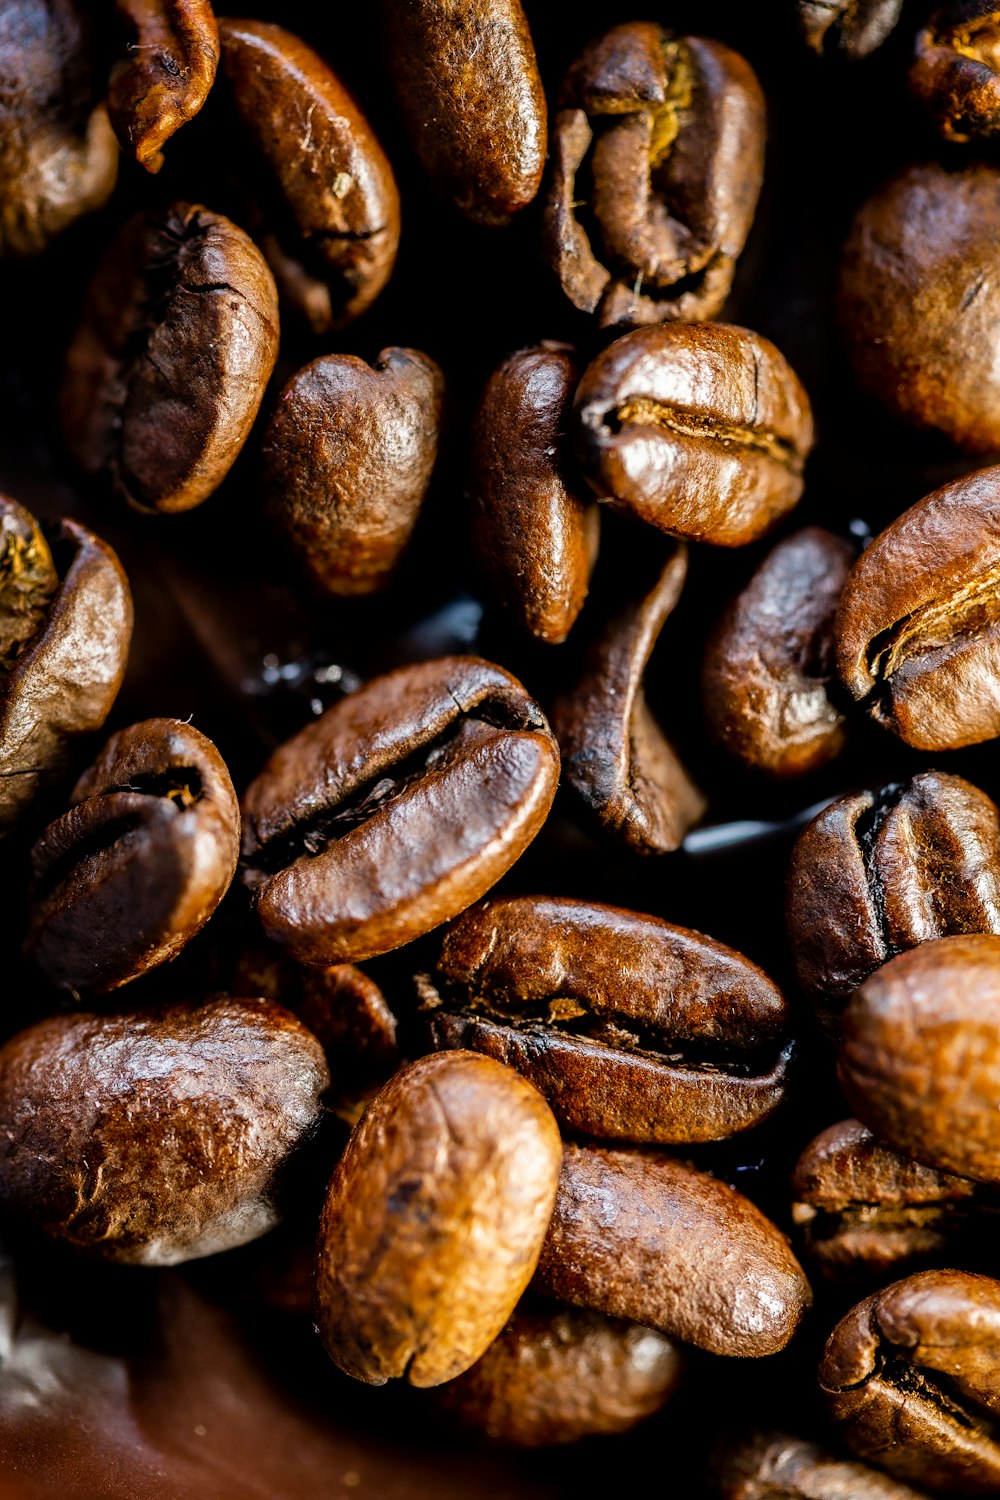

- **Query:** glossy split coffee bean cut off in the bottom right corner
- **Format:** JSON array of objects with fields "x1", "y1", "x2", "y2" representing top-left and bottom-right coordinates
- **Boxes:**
[{"x1": 820, "y1": 1271, "x2": 1000, "y2": 1496}]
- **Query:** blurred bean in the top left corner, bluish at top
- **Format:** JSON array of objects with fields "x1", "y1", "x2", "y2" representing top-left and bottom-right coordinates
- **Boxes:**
[{"x1": 0, "y1": 0, "x2": 118, "y2": 255}]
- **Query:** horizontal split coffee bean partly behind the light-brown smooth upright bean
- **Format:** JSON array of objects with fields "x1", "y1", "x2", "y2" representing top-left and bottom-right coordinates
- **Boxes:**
[{"x1": 421, "y1": 897, "x2": 789, "y2": 1143}]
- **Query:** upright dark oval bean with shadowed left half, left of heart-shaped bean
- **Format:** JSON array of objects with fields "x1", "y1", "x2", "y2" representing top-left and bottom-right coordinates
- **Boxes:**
[{"x1": 61, "y1": 204, "x2": 277, "y2": 512}]
